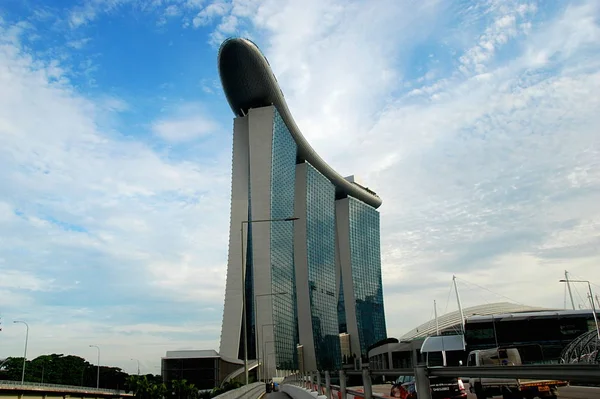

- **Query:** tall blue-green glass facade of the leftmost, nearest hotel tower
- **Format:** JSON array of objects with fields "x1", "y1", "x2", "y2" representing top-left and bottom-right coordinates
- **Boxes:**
[{"x1": 271, "y1": 110, "x2": 299, "y2": 370}]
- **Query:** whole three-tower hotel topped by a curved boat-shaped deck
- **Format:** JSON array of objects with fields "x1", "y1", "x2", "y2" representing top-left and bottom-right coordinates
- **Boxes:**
[{"x1": 218, "y1": 38, "x2": 386, "y2": 375}]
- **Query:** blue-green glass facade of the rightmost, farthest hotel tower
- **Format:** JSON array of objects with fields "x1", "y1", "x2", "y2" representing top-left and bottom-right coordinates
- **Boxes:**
[{"x1": 348, "y1": 197, "x2": 387, "y2": 356}]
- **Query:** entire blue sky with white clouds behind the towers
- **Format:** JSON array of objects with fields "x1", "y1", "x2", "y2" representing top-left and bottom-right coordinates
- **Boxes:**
[{"x1": 0, "y1": 0, "x2": 600, "y2": 372}]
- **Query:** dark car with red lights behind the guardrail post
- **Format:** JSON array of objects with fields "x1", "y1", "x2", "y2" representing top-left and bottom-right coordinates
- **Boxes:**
[{"x1": 390, "y1": 376, "x2": 467, "y2": 399}]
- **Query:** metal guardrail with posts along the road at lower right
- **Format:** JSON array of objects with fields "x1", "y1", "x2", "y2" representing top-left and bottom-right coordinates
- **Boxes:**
[{"x1": 282, "y1": 364, "x2": 600, "y2": 399}]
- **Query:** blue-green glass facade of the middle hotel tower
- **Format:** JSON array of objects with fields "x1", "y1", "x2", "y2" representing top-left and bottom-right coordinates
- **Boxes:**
[{"x1": 304, "y1": 163, "x2": 341, "y2": 370}]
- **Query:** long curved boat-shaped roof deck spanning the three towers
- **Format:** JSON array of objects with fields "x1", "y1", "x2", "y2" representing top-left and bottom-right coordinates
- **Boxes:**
[{"x1": 218, "y1": 38, "x2": 382, "y2": 208}]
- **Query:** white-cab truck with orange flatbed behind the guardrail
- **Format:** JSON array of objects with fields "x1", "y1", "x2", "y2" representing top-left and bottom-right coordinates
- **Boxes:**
[{"x1": 467, "y1": 348, "x2": 569, "y2": 399}]
